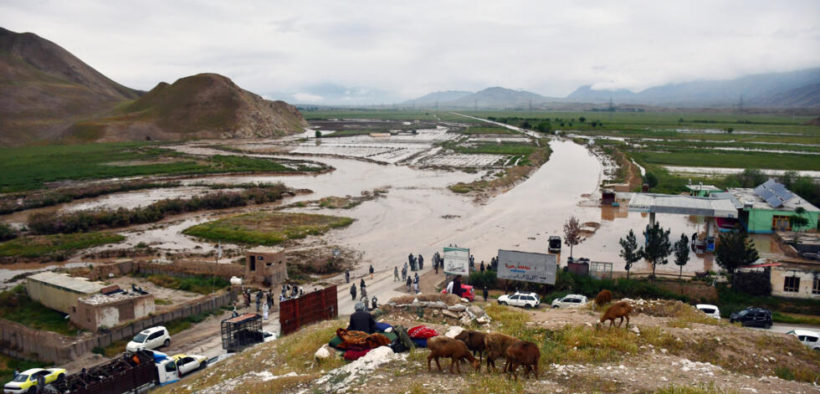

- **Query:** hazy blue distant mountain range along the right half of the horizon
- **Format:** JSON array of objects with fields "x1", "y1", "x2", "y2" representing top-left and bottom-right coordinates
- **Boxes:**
[{"x1": 402, "y1": 68, "x2": 820, "y2": 109}]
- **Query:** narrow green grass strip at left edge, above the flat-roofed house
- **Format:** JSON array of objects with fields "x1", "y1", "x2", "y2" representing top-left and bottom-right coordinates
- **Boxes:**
[{"x1": 0, "y1": 232, "x2": 125, "y2": 259}]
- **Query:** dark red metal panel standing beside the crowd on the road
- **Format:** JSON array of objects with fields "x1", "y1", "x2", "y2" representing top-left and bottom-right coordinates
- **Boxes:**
[{"x1": 279, "y1": 286, "x2": 339, "y2": 335}]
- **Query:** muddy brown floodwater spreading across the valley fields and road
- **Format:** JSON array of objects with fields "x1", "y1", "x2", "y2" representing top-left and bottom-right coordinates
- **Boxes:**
[{"x1": 4, "y1": 120, "x2": 728, "y2": 273}]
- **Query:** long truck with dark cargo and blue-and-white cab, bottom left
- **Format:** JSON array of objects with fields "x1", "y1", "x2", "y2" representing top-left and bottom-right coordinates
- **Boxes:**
[{"x1": 51, "y1": 350, "x2": 180, "y2": 394}]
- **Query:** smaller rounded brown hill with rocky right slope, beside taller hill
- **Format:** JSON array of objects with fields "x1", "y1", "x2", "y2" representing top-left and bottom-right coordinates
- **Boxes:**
[{"x1": 64, "y1": 74, "x2": 307, "y2": 141}]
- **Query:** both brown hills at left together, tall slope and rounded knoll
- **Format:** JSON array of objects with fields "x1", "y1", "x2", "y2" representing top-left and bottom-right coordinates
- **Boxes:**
[{"x1": 0, "y1": 28, "x2": 307, "y2": 145}]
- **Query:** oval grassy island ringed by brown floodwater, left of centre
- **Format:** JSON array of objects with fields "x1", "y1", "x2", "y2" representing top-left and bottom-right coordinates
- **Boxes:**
[{"x1": 183, "y1": 212, "x2": 353, "y2": 245}]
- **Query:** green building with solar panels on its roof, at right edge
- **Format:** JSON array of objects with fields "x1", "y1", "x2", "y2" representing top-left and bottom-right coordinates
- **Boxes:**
[{"x1": 729, "y1": 179, "x2": 820, "y2": 234}]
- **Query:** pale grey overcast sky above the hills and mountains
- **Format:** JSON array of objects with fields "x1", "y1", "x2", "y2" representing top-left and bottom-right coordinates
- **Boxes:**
[{"x1": 0, "y1": 0, "x2": 820, "y2": 104}]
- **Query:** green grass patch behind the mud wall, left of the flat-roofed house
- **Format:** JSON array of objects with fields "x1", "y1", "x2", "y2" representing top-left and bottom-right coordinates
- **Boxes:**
[{"x1": 0, "y1": 285, "x2": 80, "y2": 336}]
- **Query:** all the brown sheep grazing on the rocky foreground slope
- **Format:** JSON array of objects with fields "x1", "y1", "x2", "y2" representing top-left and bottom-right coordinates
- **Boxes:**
[{"x1": 427, "y1": 290, "x2": 632, "y2": 380}]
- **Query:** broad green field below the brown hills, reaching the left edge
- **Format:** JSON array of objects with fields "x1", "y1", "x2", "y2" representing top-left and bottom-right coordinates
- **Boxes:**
[{"x1": 0, "y1": 142, "x2": 317, "y2": 193}]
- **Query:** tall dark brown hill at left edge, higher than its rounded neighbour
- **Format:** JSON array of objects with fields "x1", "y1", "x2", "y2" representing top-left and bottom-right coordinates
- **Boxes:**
[{"x1": 0, "y1": 28, "x2": 140, "y2": 145}]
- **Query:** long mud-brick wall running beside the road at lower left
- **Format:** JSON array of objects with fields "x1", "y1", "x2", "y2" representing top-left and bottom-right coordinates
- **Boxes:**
[{"x1": 0, "y1": 293, "x2": 232, "y2": 363}]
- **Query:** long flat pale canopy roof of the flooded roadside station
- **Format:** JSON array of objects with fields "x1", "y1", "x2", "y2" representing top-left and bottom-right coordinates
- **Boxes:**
[{"x1": 629, "y1": 193, "x2": 738, "y2": 219}]
